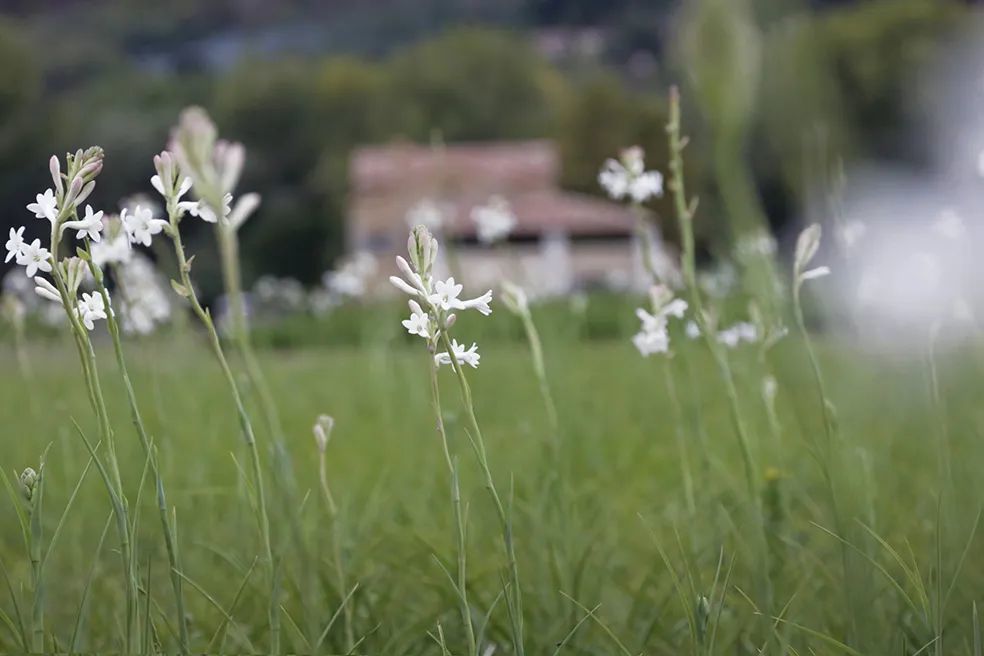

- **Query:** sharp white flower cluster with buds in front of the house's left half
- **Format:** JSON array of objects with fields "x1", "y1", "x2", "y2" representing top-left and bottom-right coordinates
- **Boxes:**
[{"x1": 390, "y1": 225, "x2": 492, "y2": 367}]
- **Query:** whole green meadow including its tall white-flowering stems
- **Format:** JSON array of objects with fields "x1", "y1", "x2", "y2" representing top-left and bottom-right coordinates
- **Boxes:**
[{"x1": 0, "y1": 96, "x2": 984, "y2": 656}]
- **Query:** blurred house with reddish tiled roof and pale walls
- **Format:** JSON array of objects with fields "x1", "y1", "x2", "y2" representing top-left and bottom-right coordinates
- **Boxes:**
[{"x1": 348, "y1": 141, "x2": 643, "y2": 294}]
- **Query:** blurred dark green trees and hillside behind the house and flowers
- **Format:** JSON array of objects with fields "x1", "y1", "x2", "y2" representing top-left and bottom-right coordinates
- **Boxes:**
[{"x1": 0, "y1": 0, "x2": 982, "y2": 298}]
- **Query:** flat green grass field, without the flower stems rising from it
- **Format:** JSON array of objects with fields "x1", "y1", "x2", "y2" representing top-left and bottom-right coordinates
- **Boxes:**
[{"x1": 0, "y1": 322, "x2": 984, "y2": 655}]
